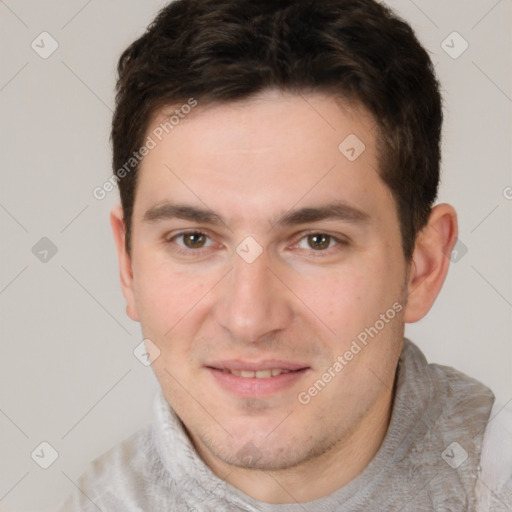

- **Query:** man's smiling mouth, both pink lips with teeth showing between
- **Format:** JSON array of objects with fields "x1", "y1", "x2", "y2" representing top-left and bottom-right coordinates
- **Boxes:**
[{"x1": 205, "y1": 360, "x2": 311, "y2": 398}]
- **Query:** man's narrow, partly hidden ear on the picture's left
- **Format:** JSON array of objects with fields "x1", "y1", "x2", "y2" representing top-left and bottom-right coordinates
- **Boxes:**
[{"x1": 110, "y1": 206, "x2": 140, "y2": 322}]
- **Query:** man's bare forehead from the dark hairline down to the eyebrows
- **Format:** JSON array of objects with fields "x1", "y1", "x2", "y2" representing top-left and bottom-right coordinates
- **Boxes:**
[{"x1": 135, "y1": 91, "x2": 387, "y2": 228}]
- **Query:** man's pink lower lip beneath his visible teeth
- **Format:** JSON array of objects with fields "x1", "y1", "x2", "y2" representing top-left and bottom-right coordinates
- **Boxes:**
[{"x1": 207, "y1": 368, "x2": 308, "y2": 398}]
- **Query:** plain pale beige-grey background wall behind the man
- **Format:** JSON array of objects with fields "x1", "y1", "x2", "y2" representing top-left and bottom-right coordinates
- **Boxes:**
[{"x1": 0, "y1": 0, "x2": 512, "y2": 512}]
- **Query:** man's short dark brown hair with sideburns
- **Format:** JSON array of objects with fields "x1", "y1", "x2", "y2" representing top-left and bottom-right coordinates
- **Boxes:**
[{"x1": 112, "y1": 0, "x2": 442, "y2": 259}]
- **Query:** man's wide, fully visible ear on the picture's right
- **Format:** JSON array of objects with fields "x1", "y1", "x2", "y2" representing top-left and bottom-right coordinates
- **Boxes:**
[{"x1": 404, "y1": 204, "x2": 458, "y2": 323}]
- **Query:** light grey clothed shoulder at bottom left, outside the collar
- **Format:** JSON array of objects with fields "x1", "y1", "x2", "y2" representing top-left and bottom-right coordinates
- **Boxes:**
[{"x1": 58, "y1": 425, "x2": 172, "y2": 512}]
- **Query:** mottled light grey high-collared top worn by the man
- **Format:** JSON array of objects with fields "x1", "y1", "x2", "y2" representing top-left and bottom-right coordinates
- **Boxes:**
[{"x1": 60, "y1": 340, "x2": 512, "y2": 512}]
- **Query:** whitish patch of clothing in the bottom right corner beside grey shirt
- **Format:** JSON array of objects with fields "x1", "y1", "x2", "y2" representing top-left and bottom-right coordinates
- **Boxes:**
[{"x1": 475, "y1": 404, "x2": 512, "y2": 512}]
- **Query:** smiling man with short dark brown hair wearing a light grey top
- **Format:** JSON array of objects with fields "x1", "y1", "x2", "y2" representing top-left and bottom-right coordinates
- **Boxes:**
[{"x1": 58, "y1": 0, "x2": 512, "y2": 512}]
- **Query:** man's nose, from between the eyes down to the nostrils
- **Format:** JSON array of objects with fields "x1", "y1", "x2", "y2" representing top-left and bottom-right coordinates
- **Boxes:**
[{"x1": 215, "y1": 247, "x2": 293, "y2": 343}]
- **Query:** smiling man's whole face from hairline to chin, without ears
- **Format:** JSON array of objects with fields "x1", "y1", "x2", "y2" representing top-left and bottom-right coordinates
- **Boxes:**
[{"x1": 120, "y1": 93, "x2": 407, "y2": 469}]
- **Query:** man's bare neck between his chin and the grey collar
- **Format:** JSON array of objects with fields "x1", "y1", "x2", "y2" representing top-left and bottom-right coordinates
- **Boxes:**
[{"x1": 194, "y1": 388, "x2": 393, "y2": 504}]
